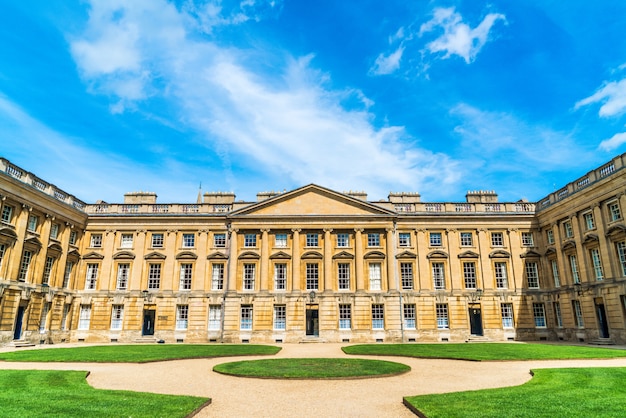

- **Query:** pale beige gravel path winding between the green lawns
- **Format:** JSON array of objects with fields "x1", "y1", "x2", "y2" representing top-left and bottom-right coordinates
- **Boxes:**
[{"x1": 0, "y1": 344, "x2": 626, "y2": 418}]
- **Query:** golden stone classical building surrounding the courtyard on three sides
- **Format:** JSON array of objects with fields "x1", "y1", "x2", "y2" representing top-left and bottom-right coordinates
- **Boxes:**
[{"x1": 0, "y1": 154, "x2": 626, "y2": 344}]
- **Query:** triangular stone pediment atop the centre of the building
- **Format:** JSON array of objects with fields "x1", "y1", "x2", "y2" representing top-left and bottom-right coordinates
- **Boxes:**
[{"x1": 230, "y1": 184, "x2": 395, "y2": 217}]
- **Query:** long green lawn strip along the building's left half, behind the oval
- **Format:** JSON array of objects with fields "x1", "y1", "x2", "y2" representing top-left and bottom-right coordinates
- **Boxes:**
[{"x1": 0, "y1": 344, "x2": 280, "y2": 363}]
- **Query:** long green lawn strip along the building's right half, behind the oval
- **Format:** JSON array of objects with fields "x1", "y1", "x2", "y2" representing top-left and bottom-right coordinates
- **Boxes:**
[{"x1": 342, "y1": 343, "x2": 626, "y2": 361}]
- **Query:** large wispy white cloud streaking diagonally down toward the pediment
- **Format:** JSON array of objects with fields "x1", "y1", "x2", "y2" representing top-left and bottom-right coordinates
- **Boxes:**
[{"x1": 67, "y1": 1, "x2": 459, "y2": 197}]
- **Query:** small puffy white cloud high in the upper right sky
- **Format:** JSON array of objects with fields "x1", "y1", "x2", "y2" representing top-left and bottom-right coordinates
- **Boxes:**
[{"x1": 419, "y1": 8, "x2": 506, "y2": 64}]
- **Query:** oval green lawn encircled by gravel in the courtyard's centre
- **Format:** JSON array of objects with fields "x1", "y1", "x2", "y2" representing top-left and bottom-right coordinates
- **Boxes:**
[{"x1": 213, "y1": 358, "x2": 411, "y2": 379}]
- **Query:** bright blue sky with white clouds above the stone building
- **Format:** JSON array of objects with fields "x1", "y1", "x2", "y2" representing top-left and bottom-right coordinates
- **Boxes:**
[{"x1": 0, "y1": 0, "x2": 626, "y2": 203}]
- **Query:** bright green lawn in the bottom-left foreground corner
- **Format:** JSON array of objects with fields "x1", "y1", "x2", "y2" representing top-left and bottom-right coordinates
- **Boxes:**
[{"x1": 0, "y1": 370, "x2": 209, "y2": 418}]
